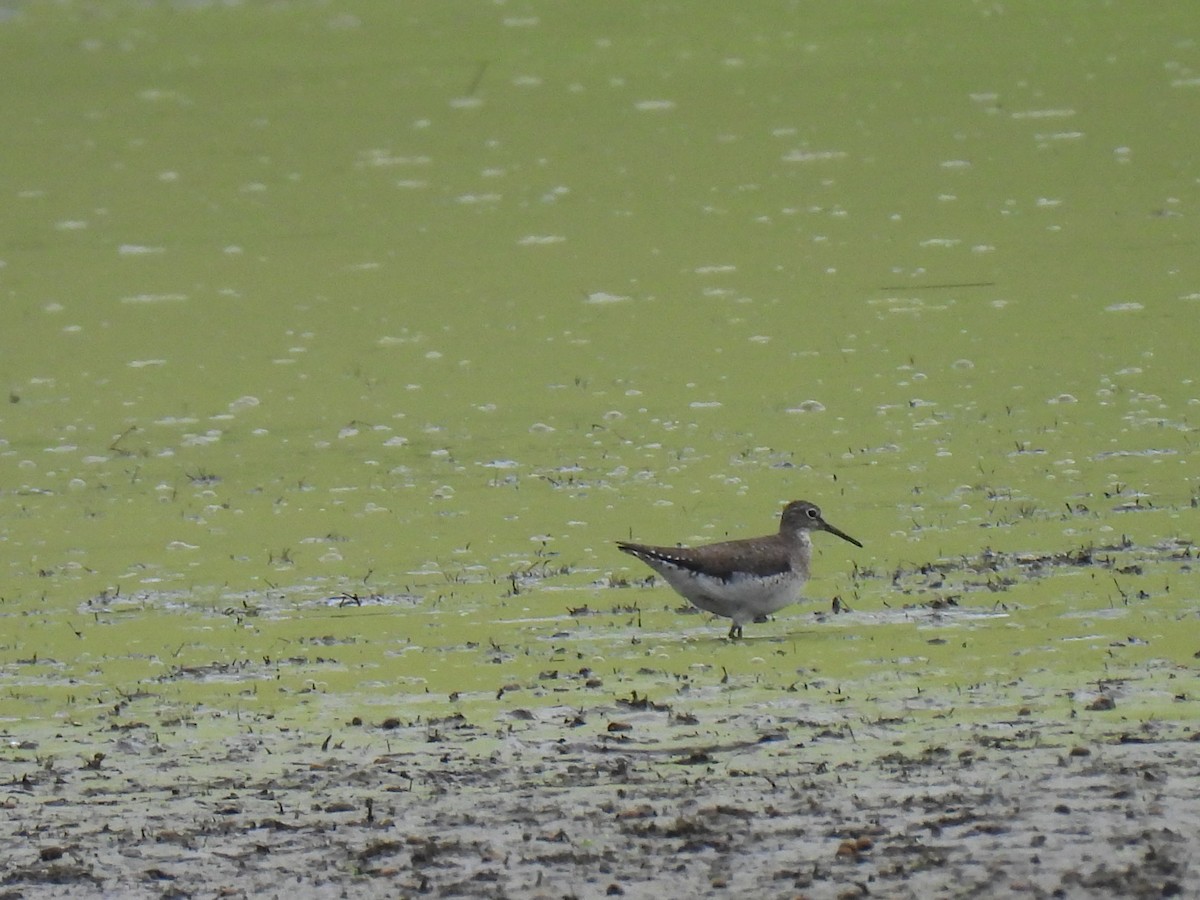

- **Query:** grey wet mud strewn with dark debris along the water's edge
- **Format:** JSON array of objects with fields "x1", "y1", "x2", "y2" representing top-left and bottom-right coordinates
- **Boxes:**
[{"x1": 0, "y1": 708, "x2": 1200, "y2": 900}]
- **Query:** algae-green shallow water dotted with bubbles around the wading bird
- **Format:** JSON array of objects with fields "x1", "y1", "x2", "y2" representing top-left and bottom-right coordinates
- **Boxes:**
[{"x1": 0, "y1": 2, "x2": 1200, "y2": 753}]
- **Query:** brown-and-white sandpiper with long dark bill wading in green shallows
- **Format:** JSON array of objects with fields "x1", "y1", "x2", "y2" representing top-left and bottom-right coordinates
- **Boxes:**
[{"x1": 617, "y1": 500, "x2": 863, "y2": 640}]
